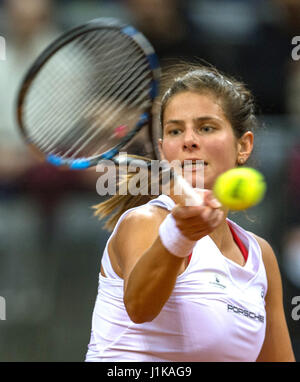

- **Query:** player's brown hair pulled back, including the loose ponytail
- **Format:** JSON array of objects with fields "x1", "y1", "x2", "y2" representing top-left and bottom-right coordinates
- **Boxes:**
[{"x1": 93, "y1": 63, "x2": 257, "y2": 231}]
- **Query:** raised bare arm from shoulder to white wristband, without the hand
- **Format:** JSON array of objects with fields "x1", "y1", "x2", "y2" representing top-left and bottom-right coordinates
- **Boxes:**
[{"x1": 115, "y1": 207, "x2": 184, "y2": 323}]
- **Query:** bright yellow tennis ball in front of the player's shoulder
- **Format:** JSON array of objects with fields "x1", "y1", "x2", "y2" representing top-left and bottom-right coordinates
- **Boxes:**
[{"x1": 213, "y1": 167, "x2": 266, "y2": 211}]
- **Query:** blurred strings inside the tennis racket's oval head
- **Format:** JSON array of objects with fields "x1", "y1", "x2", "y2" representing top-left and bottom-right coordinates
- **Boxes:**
[{"x1": 25, "y1": 31, "x2": 152, "y2": 158}]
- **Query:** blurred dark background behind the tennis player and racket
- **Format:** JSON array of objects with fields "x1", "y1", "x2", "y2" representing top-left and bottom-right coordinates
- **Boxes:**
[{"x1": 0, "y1": 0, "x2": 300, "y2": 362}]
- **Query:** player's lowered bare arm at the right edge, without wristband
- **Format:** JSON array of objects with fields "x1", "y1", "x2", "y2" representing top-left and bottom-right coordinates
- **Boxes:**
[{"x1": 256, "y1": 236, "x2": 295, "y2": 362}]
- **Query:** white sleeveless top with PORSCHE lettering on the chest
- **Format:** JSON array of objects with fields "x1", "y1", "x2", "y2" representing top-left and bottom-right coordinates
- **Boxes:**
[{"x1": 86, "y1": 195, "x2": 267, "y2": 362}]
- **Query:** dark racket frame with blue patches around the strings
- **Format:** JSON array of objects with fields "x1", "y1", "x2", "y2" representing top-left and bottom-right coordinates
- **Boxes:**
[{"x1": 16, "y1": 18, "x2": 160, "y2": 170}]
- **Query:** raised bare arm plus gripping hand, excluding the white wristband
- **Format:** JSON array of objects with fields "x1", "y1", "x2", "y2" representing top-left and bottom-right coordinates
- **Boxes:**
[{"x1": 112, "y1": 191, "x2": 223, "y2": 323}]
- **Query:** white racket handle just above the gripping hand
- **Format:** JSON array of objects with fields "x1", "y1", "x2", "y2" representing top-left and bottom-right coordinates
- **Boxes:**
[{"x1": 170, "y1": 174, "x2": 203, "y2": 206}]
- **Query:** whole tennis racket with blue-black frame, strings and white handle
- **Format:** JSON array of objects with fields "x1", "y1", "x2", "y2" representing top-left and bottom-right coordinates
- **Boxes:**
[{"x1": 16, "y1": 18, "x2": 202, "y2": 204}]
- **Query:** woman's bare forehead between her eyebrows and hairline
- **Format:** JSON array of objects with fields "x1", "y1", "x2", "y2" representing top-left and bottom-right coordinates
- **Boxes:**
[{"x1": 164, "y1": 91, "x2": 226, "y2": 122}]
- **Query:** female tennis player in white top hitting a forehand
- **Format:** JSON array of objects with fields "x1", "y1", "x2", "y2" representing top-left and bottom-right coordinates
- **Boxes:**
[{"x1": 86, "y1": 66, "x2": 295, "y2": 362}]
